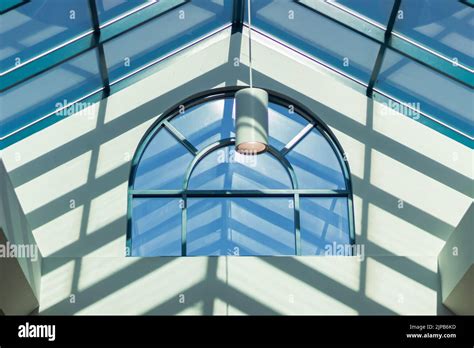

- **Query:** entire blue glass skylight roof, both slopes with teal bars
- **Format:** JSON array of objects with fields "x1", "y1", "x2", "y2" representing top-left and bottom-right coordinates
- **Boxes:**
[{"x1": 0, "y1": 0, "x2": 474, "y2": 148}]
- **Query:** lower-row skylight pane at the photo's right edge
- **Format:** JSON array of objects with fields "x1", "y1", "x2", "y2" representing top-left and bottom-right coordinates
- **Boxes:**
[{"x1": 375, "y1": 49, "x2": 474, "y2": 136}]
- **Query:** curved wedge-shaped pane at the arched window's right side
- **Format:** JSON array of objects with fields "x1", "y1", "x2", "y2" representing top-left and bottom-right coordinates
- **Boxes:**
[{"x1": 286, "y1": 128, "x2": 346, "y2": 190}]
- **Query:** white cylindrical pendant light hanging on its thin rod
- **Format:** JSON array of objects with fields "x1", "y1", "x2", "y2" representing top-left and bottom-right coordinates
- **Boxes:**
[{"x1": 235, "y1": 0, "x2": 268, "y2": 155}]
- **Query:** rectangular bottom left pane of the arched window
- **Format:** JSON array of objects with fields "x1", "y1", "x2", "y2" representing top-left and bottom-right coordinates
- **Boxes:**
[{"x1": 132, "y1": 198, "x2": 181, "y2": 256}]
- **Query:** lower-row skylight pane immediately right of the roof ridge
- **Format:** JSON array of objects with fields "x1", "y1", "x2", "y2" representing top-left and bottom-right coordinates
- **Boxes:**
[{"x1": 252, "y1": 0, "x2": 380, "y2": 83}]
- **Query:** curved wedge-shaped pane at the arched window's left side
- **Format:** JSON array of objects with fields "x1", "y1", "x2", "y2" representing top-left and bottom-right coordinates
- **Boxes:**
[{"x1": 133, "y1": 129, "x2": 193, "y2": 190}]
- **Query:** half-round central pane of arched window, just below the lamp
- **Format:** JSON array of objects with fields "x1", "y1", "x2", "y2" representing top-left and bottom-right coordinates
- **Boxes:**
[{"x1": 189, "y1": 146, "x2": 291, "y2": 190}]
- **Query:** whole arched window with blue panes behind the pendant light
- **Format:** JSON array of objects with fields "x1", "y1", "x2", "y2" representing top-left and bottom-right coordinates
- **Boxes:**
[{"x1": 127, "y1": 88, "x2": 354, "y2": 256}]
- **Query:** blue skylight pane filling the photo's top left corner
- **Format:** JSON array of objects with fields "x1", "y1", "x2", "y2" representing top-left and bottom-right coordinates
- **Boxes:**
[{"x1": 0, "y1": 0, "x2": 92, "y2": 71}]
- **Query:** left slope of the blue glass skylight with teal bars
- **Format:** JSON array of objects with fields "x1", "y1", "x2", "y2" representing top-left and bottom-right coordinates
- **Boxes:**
[{"x1": 0, "y1": 0, "x2": 233, "y2": 147}]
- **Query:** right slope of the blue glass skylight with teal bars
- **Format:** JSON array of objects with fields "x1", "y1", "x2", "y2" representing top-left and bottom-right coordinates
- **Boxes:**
[{"x1": 252, "y1": 0, "x2": 474, "y2": 147}]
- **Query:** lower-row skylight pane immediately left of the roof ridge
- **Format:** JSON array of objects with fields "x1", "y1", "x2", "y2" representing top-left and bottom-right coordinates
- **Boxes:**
[{"x1": 104, "y1": 0, "x2": 232, "y2": 81}]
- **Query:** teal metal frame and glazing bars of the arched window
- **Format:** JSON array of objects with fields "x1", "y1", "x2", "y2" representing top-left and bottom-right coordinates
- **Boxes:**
[{"x1": 126, "y1": 86, "x2": 355, "y2": 256}]
